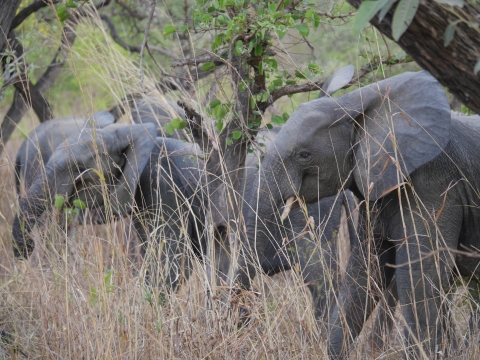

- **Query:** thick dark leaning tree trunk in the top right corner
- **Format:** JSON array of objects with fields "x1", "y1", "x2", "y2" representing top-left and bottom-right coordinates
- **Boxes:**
[{"x1": 348, "y1": 0, "x2": 480, "y2": 113}]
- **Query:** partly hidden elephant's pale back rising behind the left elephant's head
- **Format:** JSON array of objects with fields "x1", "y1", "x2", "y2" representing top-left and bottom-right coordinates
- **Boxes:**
[{"x1": 15, "y1": 111, "x2": 115, "y2": 195}]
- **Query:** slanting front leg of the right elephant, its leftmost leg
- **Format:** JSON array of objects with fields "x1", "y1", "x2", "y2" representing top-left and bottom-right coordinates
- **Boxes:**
[{"x1": 327, "y1": 204, "x2": 395, "y2": 358}]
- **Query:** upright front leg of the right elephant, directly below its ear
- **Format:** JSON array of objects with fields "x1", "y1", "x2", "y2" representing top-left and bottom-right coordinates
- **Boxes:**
[{"x1": 386, "y1": 201, "x2": 462, "y2": 357}]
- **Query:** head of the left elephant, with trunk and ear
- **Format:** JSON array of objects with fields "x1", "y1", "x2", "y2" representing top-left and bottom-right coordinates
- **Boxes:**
[{"x1": 12, "y1": 124, "x2": 156, "y2": 257}]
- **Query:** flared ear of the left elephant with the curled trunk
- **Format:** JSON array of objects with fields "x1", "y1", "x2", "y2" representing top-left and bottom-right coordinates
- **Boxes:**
[{"x1": 110, "y1": 123, "x2": 157, "y2": 215}]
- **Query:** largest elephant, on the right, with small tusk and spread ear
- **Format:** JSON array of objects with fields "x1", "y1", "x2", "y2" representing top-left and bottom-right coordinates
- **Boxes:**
[{"x1": 236, "y1": 72, "x2": 480, "y2": 357}]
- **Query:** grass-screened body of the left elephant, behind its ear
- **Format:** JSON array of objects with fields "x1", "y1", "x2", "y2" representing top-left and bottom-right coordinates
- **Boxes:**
[{"x1": 133, "y1": 137, "x2": 207, "y2": 291}]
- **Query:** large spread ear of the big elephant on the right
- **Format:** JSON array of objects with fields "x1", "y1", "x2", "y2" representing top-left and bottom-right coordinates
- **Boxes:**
[{"x1": 350, "y1": 71, "x2": 451, "y2": 201}]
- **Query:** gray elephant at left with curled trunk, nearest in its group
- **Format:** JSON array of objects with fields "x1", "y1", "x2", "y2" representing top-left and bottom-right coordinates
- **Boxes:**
[{"x1": 12, "y1": 127, "x2": 206, "y2": 290}]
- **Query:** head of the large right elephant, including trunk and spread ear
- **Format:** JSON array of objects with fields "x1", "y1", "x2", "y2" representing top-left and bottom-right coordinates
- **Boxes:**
[{"x1": 236, "y1": 71, "x2": 450, "y2": 287}]
